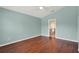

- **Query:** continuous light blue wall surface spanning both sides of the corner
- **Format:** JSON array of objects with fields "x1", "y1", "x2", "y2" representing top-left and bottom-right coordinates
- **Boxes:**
[{"x1": 0, "y1": 7, "x2": 78, "y2": 45}]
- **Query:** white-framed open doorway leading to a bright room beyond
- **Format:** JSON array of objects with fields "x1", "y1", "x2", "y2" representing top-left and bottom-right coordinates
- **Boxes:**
[{"x1": 48, "y1": 19, "x2": 56, "y2": 38}]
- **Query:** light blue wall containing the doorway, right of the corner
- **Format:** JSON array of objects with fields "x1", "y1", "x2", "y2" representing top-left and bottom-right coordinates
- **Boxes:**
[{"x1": 41, "y1": 7, "x2": 77, "y2": 40}]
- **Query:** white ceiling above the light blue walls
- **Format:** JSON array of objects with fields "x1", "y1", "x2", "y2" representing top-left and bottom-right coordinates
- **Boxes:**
[{"x1": 2, "y1": 6, "x2": 63, "y2": 18}]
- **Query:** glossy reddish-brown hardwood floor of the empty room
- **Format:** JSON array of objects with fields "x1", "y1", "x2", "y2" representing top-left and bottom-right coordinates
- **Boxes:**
[{"x1": 0, "y1": 36, "x2": 78, "y2": 53}]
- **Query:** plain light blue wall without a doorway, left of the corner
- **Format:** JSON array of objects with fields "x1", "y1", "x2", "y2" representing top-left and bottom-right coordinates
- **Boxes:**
[{"x1": 0, "y1": 8, "x2": 41, "y2": 45}]
